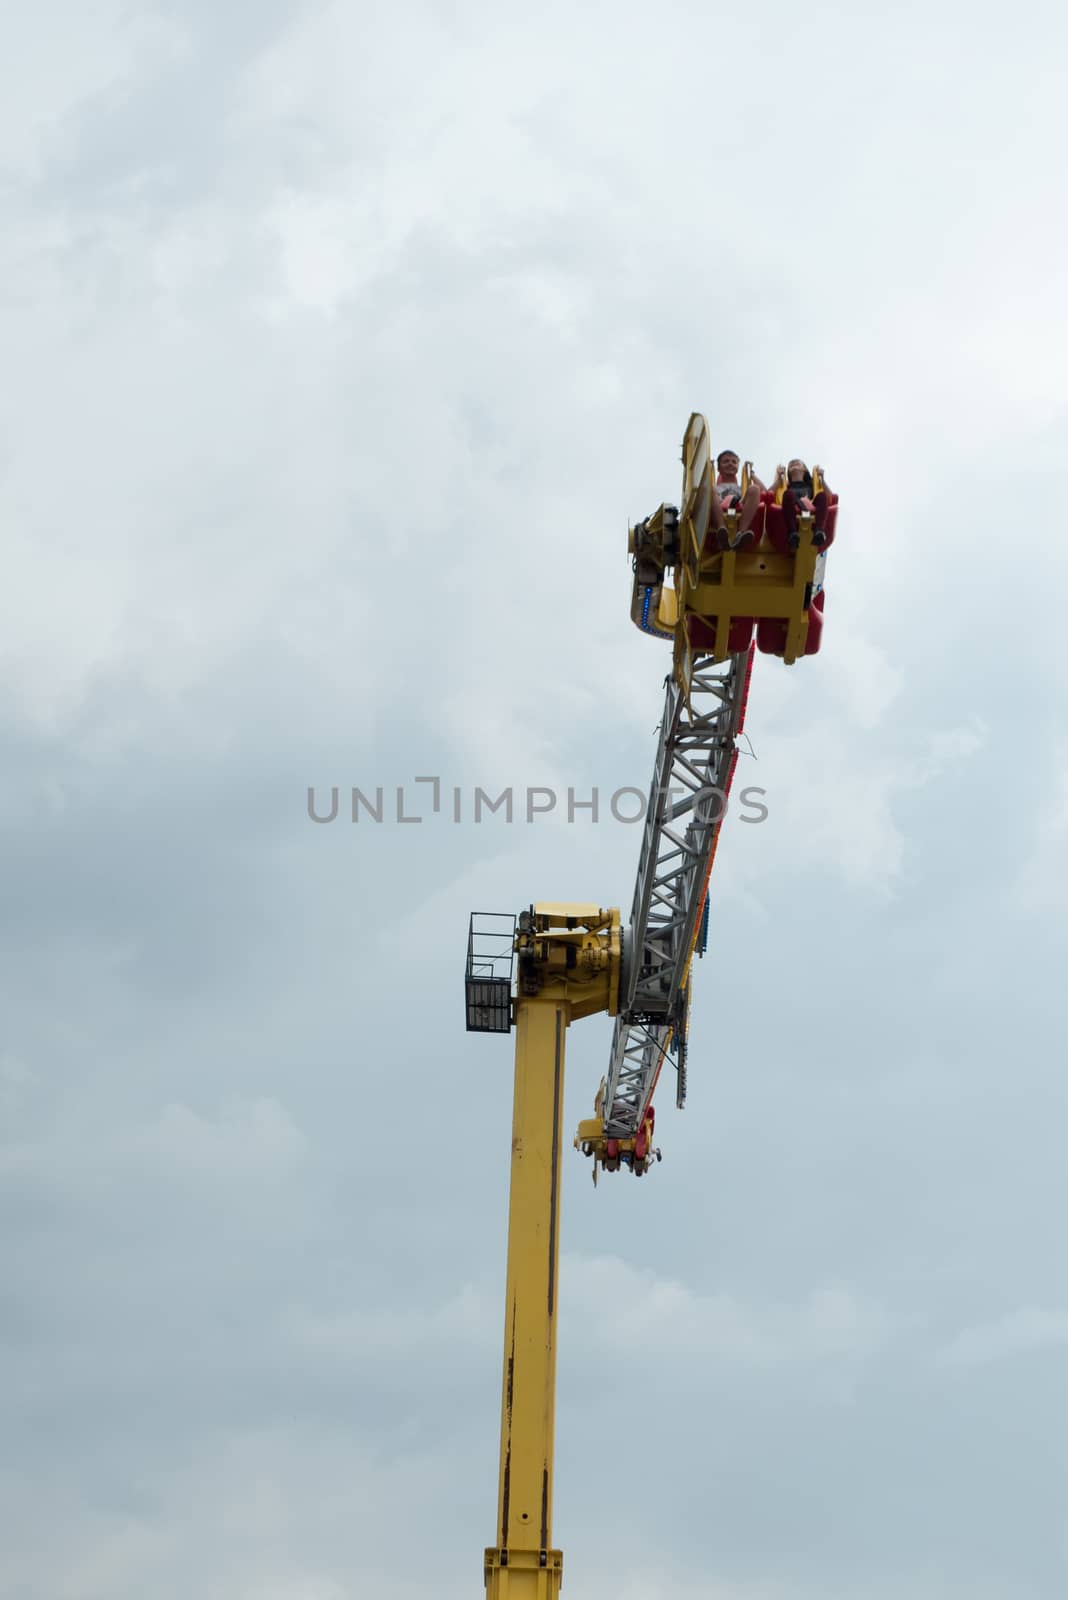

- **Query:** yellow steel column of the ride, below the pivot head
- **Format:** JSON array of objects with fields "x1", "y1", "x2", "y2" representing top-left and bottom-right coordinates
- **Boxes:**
[{"x1": 484, "y1": 997, "x2": 569, "y2": 1600}]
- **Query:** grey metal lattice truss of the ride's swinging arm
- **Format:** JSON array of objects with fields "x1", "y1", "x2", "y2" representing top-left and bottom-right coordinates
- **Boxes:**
[{"x1": 603, "y1": 650, "x2": 753, "y2": 1138}]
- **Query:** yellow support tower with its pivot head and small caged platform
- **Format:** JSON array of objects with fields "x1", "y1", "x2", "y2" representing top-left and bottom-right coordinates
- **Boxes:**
[{"x1": 468, "y1": 904, "x2": 620, "y2": 1600}]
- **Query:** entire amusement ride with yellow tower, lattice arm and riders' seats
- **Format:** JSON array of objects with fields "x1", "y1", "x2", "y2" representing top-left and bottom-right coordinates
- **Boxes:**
[{"x1": 465, "y1": 414, "x2": 838, "y2": 1600}]
